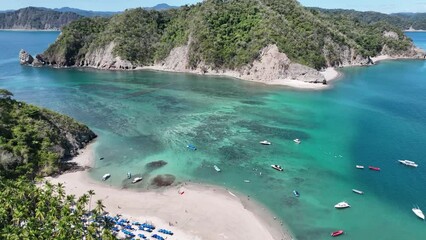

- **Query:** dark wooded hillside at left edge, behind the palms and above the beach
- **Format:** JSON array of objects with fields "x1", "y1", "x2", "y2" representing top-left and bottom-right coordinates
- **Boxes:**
[{"x1": 0, "y1": 89, "x2": 96, "y2": 179}]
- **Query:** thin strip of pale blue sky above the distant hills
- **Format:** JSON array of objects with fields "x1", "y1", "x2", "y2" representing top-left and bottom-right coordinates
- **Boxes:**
[{"x1": 0, "y1": 0, "x2": 426, "y2": 13}]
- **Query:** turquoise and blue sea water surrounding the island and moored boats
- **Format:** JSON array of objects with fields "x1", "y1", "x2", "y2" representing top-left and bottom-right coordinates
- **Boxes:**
[{"x1": 0, "y1": 31, "x2": 426, "y2": 240}]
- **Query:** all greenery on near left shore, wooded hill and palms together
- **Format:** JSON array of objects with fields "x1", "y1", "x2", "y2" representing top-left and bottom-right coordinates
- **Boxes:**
[{"x1": 0, "y1": 89, "x2": 115, "y2": 239}]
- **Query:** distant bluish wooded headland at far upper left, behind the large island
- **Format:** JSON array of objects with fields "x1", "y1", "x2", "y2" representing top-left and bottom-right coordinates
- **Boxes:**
[{"x1": 0, "y1": 7, "x2": 81, "y2": 30}]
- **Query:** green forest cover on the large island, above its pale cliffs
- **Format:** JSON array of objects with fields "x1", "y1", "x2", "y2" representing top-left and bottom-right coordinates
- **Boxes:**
[{"x1": 43, "y1": 0, "x2": 412, "y2": 69}]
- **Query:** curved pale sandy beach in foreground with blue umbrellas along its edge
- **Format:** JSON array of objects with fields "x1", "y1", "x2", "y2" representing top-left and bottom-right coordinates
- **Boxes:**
[{"x1": 46, "y1": 144, "x2": 292, "y2": 240}]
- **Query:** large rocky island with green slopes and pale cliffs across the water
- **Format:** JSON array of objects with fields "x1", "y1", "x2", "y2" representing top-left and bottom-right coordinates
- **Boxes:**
[{"x1": 21, "y1": 0, "x2": 424, "y2": 84}]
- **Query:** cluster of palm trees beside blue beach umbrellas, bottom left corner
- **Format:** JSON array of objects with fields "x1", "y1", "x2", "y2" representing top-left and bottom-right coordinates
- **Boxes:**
[{"x1": 0, "y1": 178, "x2": 115, "y2": 239}]
